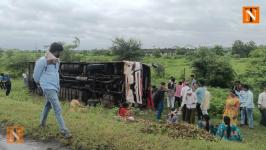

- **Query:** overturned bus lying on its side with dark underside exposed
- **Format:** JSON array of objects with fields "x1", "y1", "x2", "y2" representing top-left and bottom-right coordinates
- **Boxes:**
[{"x1": 28, "y1": 61, "x2": 151, "y2": 107}]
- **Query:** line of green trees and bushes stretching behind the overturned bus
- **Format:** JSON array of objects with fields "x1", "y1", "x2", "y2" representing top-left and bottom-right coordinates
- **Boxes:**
[{"x1": 0, "y1": 37, "x2": 266, "y2": 90}]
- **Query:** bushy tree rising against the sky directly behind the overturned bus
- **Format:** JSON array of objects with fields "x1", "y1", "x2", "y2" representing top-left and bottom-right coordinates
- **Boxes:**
[{"x1": 111, "y1": 38, "x2": 144, "y2": 61}]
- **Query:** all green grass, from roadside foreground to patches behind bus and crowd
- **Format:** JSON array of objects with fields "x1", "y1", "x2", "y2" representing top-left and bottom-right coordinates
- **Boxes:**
[{"x1": 0, "y1": 54, "x2": 266, "y2": 150}]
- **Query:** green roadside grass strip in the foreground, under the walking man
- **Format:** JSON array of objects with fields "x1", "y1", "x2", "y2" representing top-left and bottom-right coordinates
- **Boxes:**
[{"x1": 0, "y1": 80, "x2": 266, "y2": 150}]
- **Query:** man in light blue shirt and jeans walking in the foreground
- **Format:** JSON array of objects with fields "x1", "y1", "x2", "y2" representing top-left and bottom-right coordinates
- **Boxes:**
[{"x1": 33, "y1": 43, "x2": 72, "y2": 138}]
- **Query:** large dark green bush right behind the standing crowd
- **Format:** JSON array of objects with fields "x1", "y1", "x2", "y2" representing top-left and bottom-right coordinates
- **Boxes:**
[{"x1": 192, "y1": 47, "x2": 234, "y2": 88}]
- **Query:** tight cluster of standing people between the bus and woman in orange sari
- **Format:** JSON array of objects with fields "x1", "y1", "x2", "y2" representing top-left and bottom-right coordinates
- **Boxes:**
[{"x1": 152, "y1": 75, "x2": 211, "y2": 124}]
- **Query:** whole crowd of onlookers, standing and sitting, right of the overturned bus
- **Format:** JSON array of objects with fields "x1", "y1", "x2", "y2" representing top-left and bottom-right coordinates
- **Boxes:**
[{"x1": 118, "y1": 75, "x2": 266, "y2": 141}]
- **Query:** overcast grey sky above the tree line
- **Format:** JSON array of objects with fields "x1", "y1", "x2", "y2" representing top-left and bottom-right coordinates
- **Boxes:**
[{"x1": 0, "y1": 0, "x2": 266, "y2": 49}]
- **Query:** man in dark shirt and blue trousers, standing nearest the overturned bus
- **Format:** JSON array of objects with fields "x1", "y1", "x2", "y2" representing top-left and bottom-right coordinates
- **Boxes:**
[{"x1": 154, "y1": 82, "x2": 167, "y2": 121}]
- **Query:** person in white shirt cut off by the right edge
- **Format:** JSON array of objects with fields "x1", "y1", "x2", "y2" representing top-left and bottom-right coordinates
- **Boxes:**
[{"x1": 258, "y1": 85, "x2": 266, "y2": 126}]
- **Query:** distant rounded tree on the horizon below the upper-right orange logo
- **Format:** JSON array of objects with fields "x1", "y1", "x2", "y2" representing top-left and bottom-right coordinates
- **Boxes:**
[{"x1": 232, "y1": 40, "x2": 257, "y2": 57}]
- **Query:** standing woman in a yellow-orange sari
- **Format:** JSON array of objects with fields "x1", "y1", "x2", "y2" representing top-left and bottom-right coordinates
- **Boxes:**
[{"x1": 223, "y1": 91, "x2": 240, "y2": 125}]
